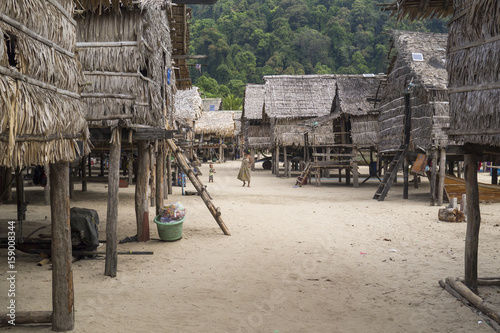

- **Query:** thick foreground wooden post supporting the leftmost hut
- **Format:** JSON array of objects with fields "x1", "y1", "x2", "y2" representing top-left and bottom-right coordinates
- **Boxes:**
[{"x1": 50, "y1": 163, "x2": 75, "y2": 332}]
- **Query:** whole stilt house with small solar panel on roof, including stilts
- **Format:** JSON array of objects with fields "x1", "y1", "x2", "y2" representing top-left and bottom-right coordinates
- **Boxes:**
[{"x1": 374, "y1": 31, "x2": 449, "y2": 202}]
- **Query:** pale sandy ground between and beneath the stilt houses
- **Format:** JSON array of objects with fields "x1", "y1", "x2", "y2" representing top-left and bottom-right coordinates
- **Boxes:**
[{"x1": 0, "y1": 161, "x2": 500, "y2": 333}]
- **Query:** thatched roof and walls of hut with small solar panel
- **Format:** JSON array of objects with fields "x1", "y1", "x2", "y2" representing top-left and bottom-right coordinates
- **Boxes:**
[{"x1": 379, "y1": 31, "x2": 449, "y2": 152}]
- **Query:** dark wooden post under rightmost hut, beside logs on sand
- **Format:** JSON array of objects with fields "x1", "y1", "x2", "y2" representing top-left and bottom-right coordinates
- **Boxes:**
[{"x1": 464, "y1": 154, "x2": 481, "y2": 293}]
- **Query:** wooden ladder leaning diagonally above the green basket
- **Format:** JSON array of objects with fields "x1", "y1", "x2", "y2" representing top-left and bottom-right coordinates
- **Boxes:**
[{"x1": 166, "y1": 139, "x2": 231, "y2": 236}]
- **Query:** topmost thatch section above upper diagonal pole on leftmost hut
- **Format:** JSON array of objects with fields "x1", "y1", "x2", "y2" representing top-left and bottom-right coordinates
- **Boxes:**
[{"x1": 0, "y1": 0, "x2": 76, "y2": 51}]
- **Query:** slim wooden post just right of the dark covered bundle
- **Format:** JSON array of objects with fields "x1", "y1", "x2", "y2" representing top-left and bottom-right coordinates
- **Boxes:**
[{"x1": 104, "y1": 129, "x2": 121, "y2": 277}]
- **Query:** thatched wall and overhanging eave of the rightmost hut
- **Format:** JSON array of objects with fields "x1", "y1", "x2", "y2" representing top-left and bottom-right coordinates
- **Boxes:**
[{"x1": 385, "y1": 0, "x2": 500, "y2": 146}]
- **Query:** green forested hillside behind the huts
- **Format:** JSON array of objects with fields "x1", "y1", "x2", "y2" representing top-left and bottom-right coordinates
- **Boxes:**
[{"x1": 190, "y1": 0, "x2": 446, "y2": 110}]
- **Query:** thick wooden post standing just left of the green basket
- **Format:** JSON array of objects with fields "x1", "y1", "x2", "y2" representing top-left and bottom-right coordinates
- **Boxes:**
[{"x1": 135, "y1": 140, "x2": 149, "y2": 242}]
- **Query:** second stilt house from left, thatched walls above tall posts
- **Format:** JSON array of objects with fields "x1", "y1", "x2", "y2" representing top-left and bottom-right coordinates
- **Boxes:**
[{"x1": 76, "y1": 0, "x2": 175, "y2": 264}]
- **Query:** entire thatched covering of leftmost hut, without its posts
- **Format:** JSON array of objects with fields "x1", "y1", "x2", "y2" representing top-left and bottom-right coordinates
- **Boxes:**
[{"x1": 0, "y1": 0, "x2": 88, "y2": 167}]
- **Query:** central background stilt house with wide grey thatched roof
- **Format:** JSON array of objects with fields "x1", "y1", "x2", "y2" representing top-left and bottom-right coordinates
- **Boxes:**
[{"x1": 264, "y1": 75, "x2": 335, "y2": 177}]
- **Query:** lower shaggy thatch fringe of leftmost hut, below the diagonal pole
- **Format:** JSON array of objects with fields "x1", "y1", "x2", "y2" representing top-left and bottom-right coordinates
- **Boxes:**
[{"x1": 0, "y1": 76, "x2": 88, "y2": 167}]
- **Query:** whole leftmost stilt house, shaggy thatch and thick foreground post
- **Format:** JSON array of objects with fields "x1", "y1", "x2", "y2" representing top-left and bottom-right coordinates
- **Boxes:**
[{"x1": 0, "y1": 0, "x2": 89, "y2": 331}]
